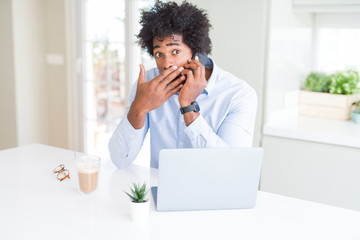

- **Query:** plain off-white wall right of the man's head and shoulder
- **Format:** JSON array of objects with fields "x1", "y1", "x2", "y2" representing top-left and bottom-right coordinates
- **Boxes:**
[{"x1": 177, "y1": 0, "x2": 268, "y2": 146}]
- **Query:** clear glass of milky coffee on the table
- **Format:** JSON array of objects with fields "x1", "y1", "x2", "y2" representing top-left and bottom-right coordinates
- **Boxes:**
[{"x1": 76, "y1": 155, "x2": 100, "y2": 194}]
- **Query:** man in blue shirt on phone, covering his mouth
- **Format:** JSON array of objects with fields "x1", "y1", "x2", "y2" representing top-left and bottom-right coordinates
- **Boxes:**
[{"x1": 109, "y1": 2, "x2": 257, "y2": 168}]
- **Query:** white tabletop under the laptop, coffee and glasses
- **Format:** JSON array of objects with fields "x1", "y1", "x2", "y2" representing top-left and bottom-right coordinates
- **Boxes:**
[{"x1": 0, "y1": 144, "x2": 360, "y2": 240}]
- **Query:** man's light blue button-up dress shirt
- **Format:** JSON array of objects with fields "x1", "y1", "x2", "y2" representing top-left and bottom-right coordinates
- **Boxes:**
[{"x1": 109, "y1": 58, "x2": 257, "y2": 168}]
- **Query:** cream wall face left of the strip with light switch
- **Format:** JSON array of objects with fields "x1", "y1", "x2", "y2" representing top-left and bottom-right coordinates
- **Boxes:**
[{"x1": 12, "y1": 0, "x2": 49, "y2": 145}]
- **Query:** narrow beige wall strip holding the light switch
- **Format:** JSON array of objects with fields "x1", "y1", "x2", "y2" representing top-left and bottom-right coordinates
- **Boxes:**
[{"x1": 43, "y1": 0, "x2": 69, "y2": 148}]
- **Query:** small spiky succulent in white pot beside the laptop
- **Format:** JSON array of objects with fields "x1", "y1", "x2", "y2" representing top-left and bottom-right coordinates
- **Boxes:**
[{"x1": 125, "y1": 183, "x2": 150, "y2": 222}]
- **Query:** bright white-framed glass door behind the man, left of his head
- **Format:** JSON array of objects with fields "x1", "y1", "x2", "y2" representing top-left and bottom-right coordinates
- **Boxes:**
[{"x1": 82, "y1": 0, "x2": 153, "y2": 161}]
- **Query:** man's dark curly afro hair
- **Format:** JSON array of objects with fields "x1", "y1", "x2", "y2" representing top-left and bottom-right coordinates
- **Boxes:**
[{"x1": 137, "y1": 1, "x2": 211, "y2": 56}]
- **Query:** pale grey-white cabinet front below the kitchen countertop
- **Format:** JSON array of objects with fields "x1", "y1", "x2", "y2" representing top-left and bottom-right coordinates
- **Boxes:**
[{"x1": 260, "y1": 136, "x2": 360, "y2": 210}]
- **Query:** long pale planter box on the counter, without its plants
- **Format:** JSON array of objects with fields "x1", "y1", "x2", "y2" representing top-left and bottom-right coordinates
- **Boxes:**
[{"x1": 299, "y1": 91, "x2": 360, "y2": 120}]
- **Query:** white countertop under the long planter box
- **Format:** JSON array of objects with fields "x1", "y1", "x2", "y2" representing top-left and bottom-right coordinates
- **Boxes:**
[{"x1": 263, "y1": 116, "x2": 360, "y2": 148}]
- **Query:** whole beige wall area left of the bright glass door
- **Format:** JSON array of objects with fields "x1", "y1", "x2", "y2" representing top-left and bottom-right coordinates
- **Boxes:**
[{"x1": 0, "y1": 0, "x2": 68, "y2": 149}]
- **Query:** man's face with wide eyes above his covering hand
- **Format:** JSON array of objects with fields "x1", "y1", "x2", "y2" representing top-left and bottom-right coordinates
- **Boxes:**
[{"x1": 153, "y1": 34, "x2": 192, "y2": 72}]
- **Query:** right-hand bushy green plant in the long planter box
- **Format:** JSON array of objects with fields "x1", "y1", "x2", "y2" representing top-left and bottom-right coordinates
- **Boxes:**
[{"x1": 329, "y1": 70, "x2": 360, "y2": 95}]
